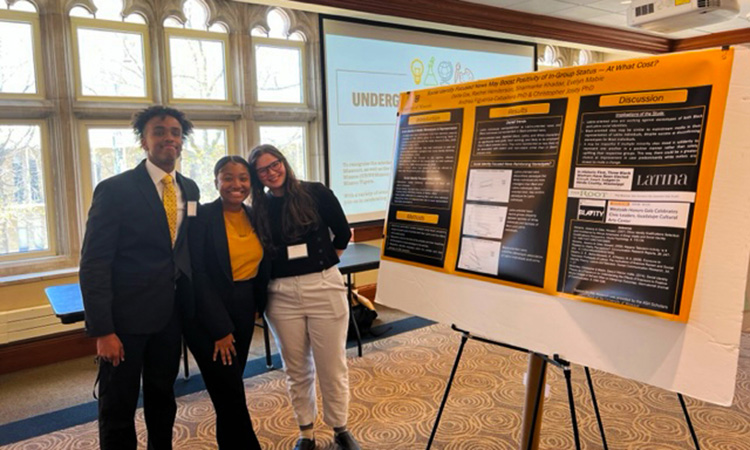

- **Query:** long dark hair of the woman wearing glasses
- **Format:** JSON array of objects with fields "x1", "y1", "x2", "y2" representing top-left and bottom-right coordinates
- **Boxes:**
[{"x1": 247, "y1": 144, "x2": 319, "y2": 250}]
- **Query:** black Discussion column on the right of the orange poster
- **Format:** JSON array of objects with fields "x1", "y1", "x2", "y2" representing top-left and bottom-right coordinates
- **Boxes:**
[{"x1": 558, "y1": 86, "x2": 711, "y2": 314}]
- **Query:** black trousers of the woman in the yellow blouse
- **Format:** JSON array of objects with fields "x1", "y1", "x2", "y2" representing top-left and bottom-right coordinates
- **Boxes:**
[{"x1": 184, "y1": 280, "x2": 260, "y2": 450}]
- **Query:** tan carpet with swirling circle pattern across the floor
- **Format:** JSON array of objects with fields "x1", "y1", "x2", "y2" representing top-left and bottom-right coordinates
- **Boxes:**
[{"x1": 0, "y1": 325, "x2": 750, "y2": 450}]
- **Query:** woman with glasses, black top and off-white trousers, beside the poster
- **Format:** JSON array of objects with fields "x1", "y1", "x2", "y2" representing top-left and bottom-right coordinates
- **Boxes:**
[{"x1": 248, "y1": 145, "x2": 360, "y2": 450}]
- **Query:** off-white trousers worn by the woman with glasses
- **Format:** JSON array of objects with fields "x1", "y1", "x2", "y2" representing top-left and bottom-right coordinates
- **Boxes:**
[{"x1": 266, "y1": 266, "x2": 349, "y2": 427}]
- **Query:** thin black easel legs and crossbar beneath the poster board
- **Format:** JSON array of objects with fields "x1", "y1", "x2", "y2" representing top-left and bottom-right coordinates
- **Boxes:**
[{"x1": 426, "y1": 325, "x2": 607, "y2": 450}]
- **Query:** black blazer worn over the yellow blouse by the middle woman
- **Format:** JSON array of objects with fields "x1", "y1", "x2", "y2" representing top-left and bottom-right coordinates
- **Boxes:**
[{"x1": 189, "y1": 198, "x2": 271, "y2": 340}]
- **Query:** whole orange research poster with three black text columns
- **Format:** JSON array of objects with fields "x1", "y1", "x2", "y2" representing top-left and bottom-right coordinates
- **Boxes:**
[{"x1": 383, "y1": 49, "x2": 733, "y2": 321}]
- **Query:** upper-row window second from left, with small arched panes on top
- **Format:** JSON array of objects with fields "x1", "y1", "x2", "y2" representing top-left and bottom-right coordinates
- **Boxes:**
[{"x1": 70, "y1": 0, "x2": 151, "y2": 100}]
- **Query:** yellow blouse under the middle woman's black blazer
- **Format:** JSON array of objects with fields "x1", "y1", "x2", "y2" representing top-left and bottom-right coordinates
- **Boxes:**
[{"x1": 224, "y1": 210, "x2": 263, "y2": 281}]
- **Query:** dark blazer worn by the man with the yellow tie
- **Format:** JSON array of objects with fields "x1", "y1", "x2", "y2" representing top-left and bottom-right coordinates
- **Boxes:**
[{"x1": 79, "y1": 160, "x2": 200, "y2": 337}]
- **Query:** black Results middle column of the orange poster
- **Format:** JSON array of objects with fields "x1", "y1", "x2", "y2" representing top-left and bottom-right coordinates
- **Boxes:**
[{"x1": 456, "y1": 98, "x2": 567, "y2": 287}]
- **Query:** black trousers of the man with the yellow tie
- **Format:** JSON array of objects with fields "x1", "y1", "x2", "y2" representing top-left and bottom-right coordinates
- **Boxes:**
[{"x1": 99, "y1": 308, "x2": 182, "y2": 450}]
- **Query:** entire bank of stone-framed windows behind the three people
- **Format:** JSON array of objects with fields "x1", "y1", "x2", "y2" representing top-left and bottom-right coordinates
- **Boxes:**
[{"x1": 0, "y1": 0, "x2": 323, "y2": 279}]
